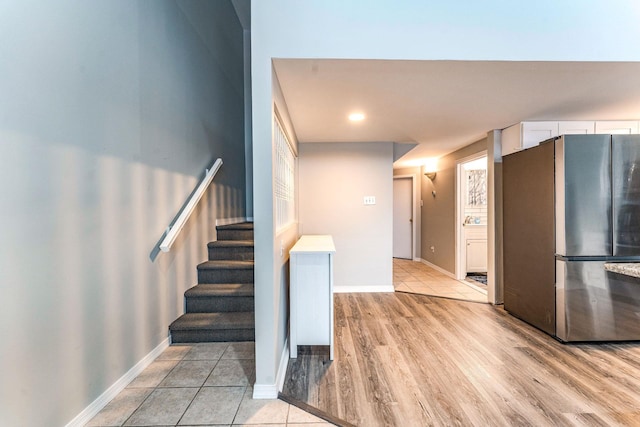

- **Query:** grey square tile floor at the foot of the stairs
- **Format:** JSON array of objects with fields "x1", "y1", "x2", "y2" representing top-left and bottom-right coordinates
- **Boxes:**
[{"x1": 86, "y1": 342, "x2": 331, "y2": 427}]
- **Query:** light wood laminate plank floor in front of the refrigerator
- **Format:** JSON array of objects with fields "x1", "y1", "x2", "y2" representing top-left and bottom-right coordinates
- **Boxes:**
[{"x1": 283, "y1": 293, "x2": 640, "y2": 427}]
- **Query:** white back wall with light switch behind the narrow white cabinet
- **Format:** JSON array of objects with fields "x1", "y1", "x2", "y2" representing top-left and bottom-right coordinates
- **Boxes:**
[{"x1": 299, "y1": 142, "x2": 393, "y2": 292}]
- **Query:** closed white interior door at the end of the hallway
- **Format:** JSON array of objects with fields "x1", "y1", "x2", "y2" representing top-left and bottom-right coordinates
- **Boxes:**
[{"x1": 393, "y1": 178, "x2": 413, "y2": 259}]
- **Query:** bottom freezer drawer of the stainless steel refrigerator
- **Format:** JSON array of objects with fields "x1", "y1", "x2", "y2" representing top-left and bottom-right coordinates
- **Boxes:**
[{"x1": 556, "y1": 260, "x2": 640, "y2": 342}]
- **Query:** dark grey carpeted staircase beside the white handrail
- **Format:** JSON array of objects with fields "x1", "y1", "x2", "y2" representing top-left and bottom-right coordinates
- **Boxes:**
[{"x1": 169, "y1": 222, "x2": 255, "y2": 343}]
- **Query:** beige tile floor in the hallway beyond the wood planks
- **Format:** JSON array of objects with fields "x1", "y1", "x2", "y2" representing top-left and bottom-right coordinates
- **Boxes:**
[{"x1": 393, "y1": 258, "x2": 487, "y2": 303}]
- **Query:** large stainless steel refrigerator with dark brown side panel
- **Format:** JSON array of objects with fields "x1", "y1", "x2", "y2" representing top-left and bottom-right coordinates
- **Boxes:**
[{"x1": 503, "y1": 135, "x2": 640, "y2": 341}]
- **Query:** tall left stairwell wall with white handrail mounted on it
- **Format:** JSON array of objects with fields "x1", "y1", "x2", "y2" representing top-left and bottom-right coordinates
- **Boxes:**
[{"x1": 0, "y1": 0, "x2": 245, "y2": 427}]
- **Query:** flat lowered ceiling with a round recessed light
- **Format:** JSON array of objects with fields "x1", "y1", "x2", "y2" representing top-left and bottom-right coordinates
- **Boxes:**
[{"x1": 273, "y1": 59, "x2": 640, "y2": 167}]
